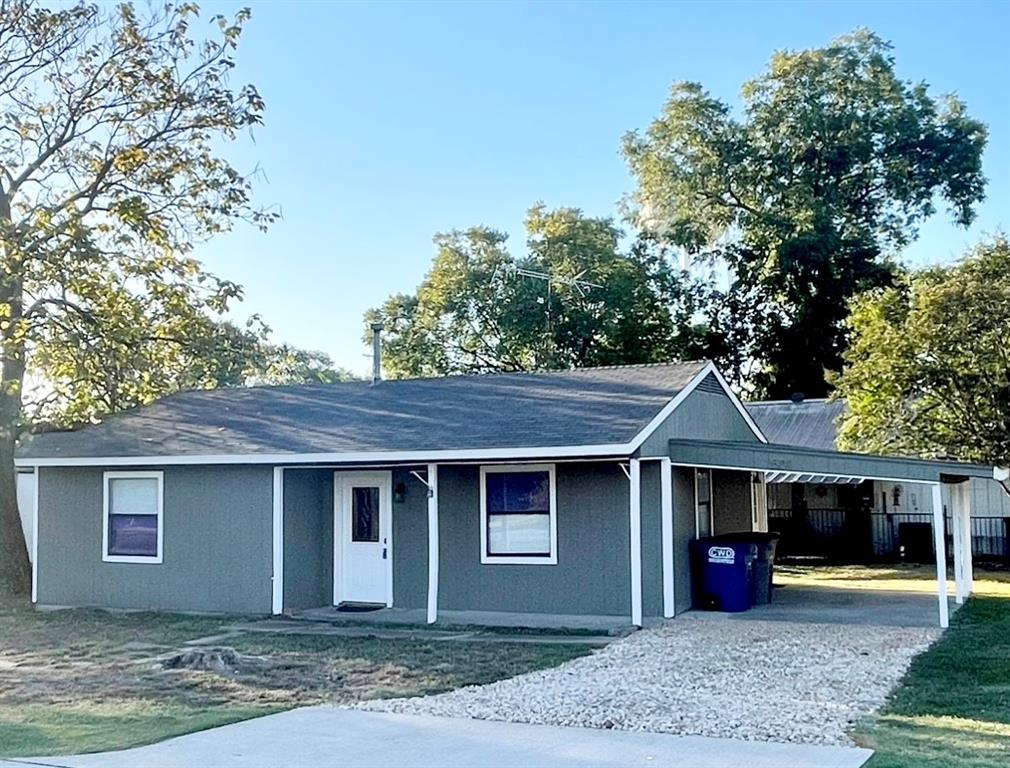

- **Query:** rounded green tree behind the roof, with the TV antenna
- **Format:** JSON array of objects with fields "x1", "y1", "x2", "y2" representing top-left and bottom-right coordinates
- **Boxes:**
[{"x1": 366, "y1": 205, "x2": 710, "y2": 376}]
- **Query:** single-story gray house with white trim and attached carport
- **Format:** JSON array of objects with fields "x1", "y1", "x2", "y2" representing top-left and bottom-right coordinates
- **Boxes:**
[{"x1": 16, "y1": 362, "x2": 1002, "y2": 626}]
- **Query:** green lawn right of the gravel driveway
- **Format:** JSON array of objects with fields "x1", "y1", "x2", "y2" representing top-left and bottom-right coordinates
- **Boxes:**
[{"x1": 856, "y1": 597, "x2": 1010, "y2": 768}]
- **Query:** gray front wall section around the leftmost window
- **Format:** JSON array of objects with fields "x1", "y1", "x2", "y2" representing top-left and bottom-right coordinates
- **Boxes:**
[{"x1": 37, "y1": 465, "x2": 273, "y2": 613}]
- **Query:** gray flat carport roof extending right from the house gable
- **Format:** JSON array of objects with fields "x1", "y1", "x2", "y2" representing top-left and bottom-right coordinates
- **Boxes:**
[{"x1": 670, "y1": 439, "x2": 998, "y2": 483}]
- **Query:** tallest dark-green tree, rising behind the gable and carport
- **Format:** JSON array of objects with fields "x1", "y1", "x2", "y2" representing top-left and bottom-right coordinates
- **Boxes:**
[{"x1": 624, "y1": 30, "x2": 986, "y2": 397}]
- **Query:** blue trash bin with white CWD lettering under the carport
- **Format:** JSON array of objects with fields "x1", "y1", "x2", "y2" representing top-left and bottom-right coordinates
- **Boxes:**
[{"x1": 691, "y1": 537, "x2": 758, "y2": 613}]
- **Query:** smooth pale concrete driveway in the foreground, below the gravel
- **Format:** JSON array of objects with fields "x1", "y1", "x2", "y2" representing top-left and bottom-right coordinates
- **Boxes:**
[{"x1": 0, "y1": 706, "x2": 872, "y2": 768}]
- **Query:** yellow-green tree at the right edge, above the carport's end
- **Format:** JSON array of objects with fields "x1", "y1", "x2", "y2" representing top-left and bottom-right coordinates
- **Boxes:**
[{"x1": 836, "y1": 235, "x2": 1010, "y2": 467}]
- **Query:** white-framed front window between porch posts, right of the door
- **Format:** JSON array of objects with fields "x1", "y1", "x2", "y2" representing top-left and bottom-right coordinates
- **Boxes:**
[{"x1": 481, "y1": 464, "x2": 558, "y2": 565}]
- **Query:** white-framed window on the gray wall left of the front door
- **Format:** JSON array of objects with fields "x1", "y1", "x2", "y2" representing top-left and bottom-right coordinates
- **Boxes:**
[{"x1": 102, "y1": 472, "x2": 164, "y2": 563}]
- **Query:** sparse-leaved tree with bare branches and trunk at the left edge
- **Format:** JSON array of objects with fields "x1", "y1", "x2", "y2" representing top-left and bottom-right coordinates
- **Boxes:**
[{"x1": 0, "y1": 0, "x2": 272, "y2": 591}]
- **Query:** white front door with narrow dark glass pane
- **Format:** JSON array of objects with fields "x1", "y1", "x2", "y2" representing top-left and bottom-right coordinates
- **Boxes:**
[{"x1": 333, "y1": 472, "x2": 393, "y2": 605}]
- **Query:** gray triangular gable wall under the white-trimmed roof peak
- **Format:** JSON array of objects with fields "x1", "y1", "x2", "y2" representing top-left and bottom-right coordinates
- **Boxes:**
[{"x1": 638, "y1": 389, "x2": 759, "y2": 458}]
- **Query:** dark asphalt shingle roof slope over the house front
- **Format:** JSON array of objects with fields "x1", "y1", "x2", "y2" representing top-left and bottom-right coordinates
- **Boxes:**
[{"x1": 18, "y1": 362, "x2": 706, "y2": 458}]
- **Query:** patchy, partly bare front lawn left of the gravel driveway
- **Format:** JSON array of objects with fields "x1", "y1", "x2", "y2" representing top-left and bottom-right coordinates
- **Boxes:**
[{"x1": 0, "y1": 603, "x2": 590, "y2": 757}]
